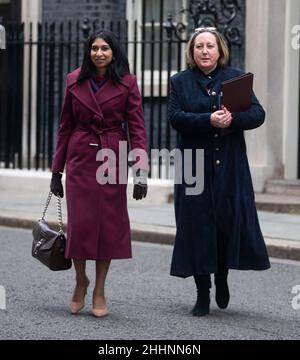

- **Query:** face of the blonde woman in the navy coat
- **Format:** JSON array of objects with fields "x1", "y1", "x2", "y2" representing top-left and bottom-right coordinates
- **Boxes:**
[{"x1": 194, "y1": 32, "x2": 220, "y2": 74}]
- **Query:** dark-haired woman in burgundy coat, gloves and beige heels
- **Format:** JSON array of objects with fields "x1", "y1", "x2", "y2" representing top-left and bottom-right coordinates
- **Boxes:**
[{"x1": 50, "y1": 31, "x2": 147, "y2": 317}]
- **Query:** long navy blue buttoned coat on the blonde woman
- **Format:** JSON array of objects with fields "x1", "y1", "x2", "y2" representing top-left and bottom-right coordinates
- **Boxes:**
[{"x1": 168, "y1": 67, "x2": 270, "y2": 277}]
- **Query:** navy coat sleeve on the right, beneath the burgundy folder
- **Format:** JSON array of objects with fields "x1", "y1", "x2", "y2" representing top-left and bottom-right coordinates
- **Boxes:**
[{"x1": 229, "y1": 93, "x2": 266, "y2": 130}]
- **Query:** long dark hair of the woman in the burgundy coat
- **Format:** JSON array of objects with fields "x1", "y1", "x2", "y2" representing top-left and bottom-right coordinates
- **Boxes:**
[{"x1": 77, "y1": 30, "x2": 129, "y2": 84}]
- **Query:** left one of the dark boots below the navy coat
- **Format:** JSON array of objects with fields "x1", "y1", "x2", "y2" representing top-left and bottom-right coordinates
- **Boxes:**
[{"x1": 192, "y1": 275, "x2": 211, "y2": 316}]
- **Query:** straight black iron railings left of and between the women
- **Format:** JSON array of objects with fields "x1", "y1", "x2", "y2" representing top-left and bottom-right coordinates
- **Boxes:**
[{"x1": 0, "y1": 22, "x2": 184, "y2": 174}]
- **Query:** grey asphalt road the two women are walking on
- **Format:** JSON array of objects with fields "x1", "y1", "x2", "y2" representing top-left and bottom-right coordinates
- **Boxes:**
[{"x1": 0, "y1": 227, "x2": 300, "y2": 338}]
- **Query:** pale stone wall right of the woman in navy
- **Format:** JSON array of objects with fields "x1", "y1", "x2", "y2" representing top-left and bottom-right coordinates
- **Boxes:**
[{"x1": 246, "y1": 0, "x2": 300, "y2": 191}]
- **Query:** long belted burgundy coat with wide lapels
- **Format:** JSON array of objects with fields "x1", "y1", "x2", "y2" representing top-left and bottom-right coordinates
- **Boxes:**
[{"x1": 52, "y1": 68, "x2": 147, "y2": 260}]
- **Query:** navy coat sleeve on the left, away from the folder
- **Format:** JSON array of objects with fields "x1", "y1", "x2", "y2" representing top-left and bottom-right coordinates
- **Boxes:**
[{"x1": 168, "y1": 79, "x2": 212, "y2": 133}]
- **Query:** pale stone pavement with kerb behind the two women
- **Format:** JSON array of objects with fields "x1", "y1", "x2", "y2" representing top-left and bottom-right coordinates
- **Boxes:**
[{"x1": 0, "y1": 170, "x2": 300, "y2": 261}]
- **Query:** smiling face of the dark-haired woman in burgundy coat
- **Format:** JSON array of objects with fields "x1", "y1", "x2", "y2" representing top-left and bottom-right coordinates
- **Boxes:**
[{"x1": 90, "y1": 38, "x2": 113, "y2": 75}]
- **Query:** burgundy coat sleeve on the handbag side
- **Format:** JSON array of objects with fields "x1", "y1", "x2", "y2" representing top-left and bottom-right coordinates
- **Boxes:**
[{"x1": 51, "y1": 82, "x2": 74, "y2": 172}]
